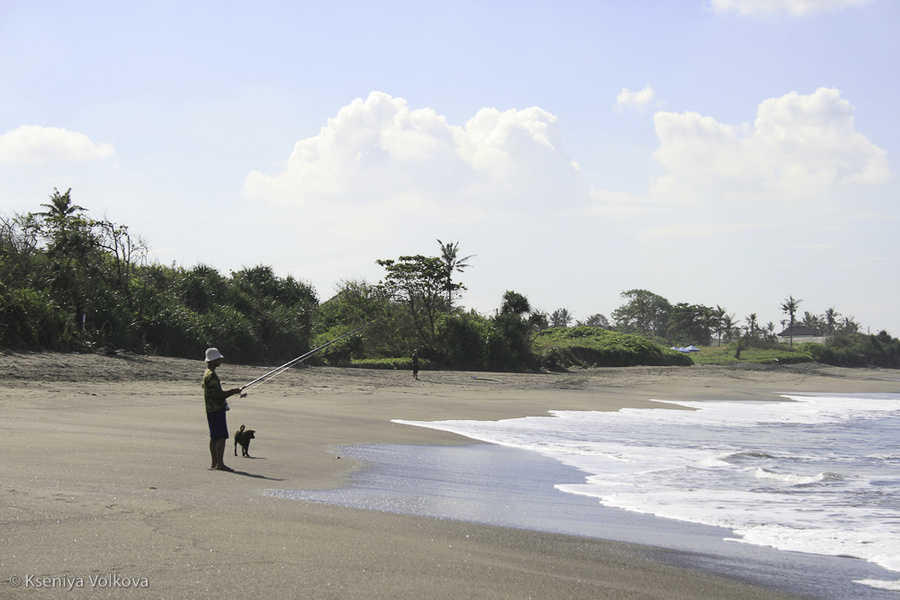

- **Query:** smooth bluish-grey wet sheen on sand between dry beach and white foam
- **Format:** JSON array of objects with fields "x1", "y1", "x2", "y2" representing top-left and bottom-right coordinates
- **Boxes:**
[{"x1": 286, "y1": 440, "x2": 897, "y2": 600}]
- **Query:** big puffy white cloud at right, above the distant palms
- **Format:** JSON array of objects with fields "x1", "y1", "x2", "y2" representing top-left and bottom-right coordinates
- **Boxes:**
[{"x1": 654, "y1": 88, "x2": 890, "y2": 200}]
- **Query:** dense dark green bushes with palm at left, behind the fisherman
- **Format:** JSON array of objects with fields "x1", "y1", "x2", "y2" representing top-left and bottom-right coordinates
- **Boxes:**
[{"x1": 0, "y1": 191, "x2": 317, "y2": 364}]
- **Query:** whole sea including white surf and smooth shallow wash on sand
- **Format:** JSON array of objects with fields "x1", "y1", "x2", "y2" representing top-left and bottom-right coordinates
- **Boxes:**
[{"x1": 278, "y1": 394, "x2": 900, "y2": 599}]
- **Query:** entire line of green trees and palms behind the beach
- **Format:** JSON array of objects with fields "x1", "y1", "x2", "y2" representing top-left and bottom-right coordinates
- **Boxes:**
[{"x1": 0, "y1": 190, "x2": 890, "y2": 371}]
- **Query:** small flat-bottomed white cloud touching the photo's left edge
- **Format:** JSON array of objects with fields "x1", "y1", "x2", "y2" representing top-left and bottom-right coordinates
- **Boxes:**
[{"x1": 0, "y1": 125, "x2": 114, "y2": 164}]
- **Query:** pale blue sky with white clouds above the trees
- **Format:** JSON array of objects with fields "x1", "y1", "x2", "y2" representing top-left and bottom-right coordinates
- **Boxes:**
[{"x1": 0, "y1": 0, "x2": 900, "y2": 336}]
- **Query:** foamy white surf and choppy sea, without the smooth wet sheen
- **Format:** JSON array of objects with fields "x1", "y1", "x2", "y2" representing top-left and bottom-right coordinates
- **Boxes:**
[{"x1": 396, "y1": 394, "x2": 900, "y2": 589}]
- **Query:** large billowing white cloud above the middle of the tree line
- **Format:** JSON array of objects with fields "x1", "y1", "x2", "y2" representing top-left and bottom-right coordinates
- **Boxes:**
[{"x1": 244, "y1": 92, "x2": 587, "y2": 228}]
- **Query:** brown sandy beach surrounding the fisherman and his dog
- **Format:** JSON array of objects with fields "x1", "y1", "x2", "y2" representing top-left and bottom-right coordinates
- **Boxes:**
[{"x1": 0, "y1": 353, "x2": 898, "y2": 600}]
